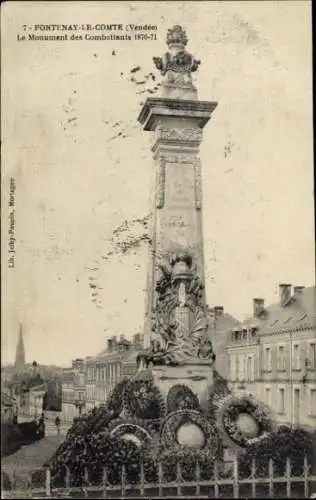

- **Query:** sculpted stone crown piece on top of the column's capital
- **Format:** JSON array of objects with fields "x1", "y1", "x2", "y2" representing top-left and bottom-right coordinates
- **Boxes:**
[{"x1": 153, "y1": 26, "x2": 201, "y2": 92}]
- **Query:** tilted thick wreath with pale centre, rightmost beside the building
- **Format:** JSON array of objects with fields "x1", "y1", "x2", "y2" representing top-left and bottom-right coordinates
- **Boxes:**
[{"x1": 216, "y1": 395, "x2": 275, "y2": 448}]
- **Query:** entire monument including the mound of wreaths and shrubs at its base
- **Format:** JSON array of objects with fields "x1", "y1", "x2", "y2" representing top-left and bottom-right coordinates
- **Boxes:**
[{"x1": 46, "y1": 26, "x2": 274, "y2": 485}]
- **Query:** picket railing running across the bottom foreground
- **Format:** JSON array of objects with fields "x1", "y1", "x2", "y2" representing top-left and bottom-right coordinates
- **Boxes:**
[{"x1": 2, "y1": 457, "x2": 316, "y2": 499}]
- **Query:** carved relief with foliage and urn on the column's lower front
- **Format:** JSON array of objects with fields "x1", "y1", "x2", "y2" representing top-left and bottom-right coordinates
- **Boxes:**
[{"x1": 144, "y1": 251, "x2": 214, "y2": 365}]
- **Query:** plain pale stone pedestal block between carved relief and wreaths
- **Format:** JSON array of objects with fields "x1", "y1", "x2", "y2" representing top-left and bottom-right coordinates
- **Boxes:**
[{"x1": 151, "y1": 359, "x2": 213, "y2": 406}]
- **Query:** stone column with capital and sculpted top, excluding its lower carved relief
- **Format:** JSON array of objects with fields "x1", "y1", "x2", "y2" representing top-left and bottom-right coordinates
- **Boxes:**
[{"x1": 138, "y1": 26, "x2": 217, "y2": 347}]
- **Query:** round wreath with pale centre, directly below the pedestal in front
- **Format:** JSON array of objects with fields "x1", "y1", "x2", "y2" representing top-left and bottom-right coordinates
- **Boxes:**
[{"x1": 161, "y1": 410, "x2": 219, "y2": 457}]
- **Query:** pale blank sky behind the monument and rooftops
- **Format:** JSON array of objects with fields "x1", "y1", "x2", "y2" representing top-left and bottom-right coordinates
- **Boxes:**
[{"x1": 1, "y1": 1, "x2": 315, "y2": 366}]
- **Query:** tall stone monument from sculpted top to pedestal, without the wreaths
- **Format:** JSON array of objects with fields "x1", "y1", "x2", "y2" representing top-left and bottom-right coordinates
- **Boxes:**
[{"x1": 138, "y1": 26, "x2": 217, "y2": 402}]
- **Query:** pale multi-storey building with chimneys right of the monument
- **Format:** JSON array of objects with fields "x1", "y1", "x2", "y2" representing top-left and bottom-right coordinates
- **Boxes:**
[{"x1": 227, "y1": 284, "x2": 316, "y2": 428}]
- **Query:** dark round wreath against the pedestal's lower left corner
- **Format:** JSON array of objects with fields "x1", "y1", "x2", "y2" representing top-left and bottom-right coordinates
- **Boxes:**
[{"x1": 123, "y1": 380, "x2": 166, "y2": 420}]
